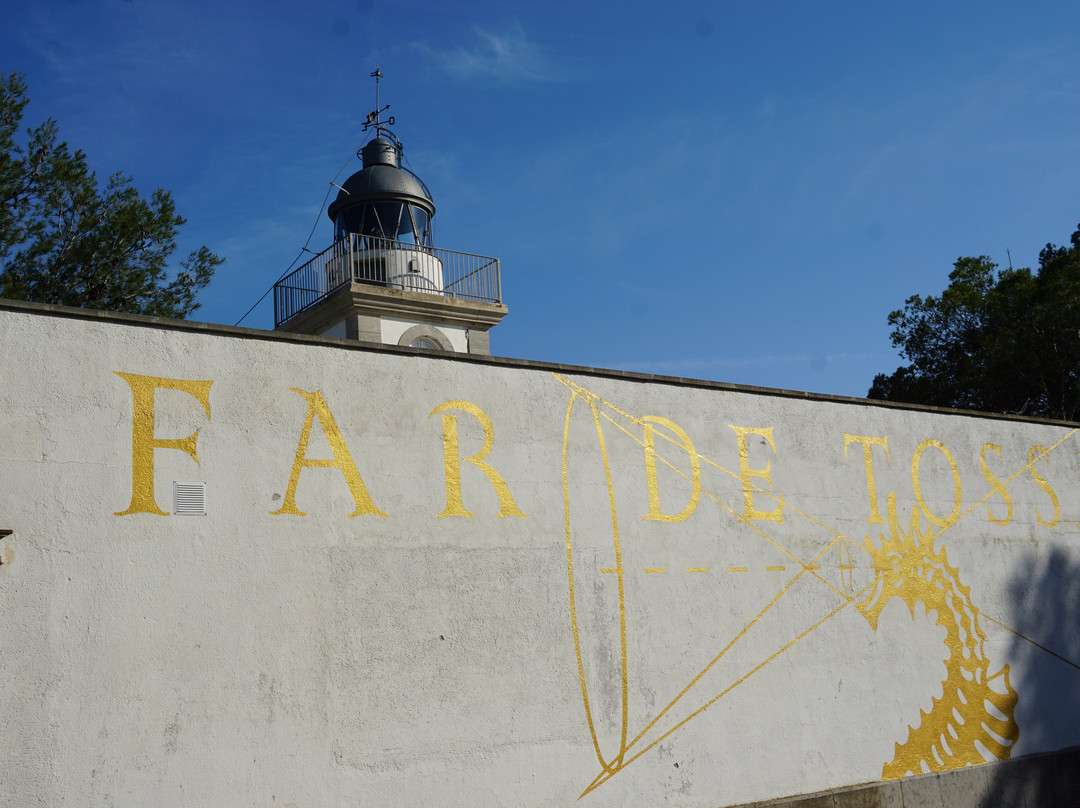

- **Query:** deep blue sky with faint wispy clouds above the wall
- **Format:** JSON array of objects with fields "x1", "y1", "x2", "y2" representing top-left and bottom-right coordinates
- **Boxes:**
[{"x1": 6, "y1": 0, "x2": 1080, "y2": 395}]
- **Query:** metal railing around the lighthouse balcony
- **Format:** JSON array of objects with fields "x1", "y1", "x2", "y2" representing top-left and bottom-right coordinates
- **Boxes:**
[{"x1": 273, "y1": 233, "x2": 502, "y2": 327}]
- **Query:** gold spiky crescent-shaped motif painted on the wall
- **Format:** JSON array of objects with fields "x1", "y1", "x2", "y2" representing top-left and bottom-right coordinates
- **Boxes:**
[{"x1": 856, "y1": 495, "x2": 1020, "y2": 780}]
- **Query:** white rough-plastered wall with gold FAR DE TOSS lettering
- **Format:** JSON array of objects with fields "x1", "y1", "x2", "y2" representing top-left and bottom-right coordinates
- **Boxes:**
[{"x1": 0, "y1": 309, "x2": 1080, "y2": 808}]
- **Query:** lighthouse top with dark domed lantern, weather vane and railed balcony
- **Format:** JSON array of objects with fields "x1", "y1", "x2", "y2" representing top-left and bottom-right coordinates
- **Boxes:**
[{"x1": 274, "y1": 68, "x2": 507, "y2": 354}]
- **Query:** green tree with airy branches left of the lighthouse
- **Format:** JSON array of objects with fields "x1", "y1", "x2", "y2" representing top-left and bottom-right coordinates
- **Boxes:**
[{"x1": 0, "y1": 72, "x2": 224, "y2": 319}]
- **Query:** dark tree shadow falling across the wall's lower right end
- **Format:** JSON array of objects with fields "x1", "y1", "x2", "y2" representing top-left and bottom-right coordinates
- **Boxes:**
[{"x1": 983, "y1": 548, "x2": 1080, "y2": 808}]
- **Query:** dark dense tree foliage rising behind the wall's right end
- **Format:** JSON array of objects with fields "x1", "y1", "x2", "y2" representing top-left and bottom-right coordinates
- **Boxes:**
[{"x1": 868, "y1": 225, "x2": 1080, "y2": 420}]
